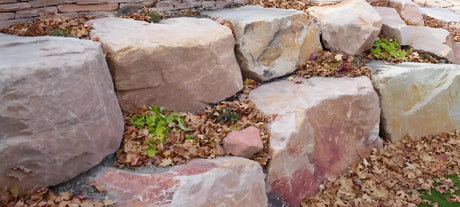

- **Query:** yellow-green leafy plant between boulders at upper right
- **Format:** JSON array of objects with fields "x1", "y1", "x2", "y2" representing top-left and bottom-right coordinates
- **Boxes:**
[{"x1": 370, "y1": 38, "x2": 408, "y2": 61}]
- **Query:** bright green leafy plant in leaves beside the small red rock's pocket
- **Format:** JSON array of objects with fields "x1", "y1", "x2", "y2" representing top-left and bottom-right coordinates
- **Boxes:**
[{"x1": 131, "y1": 105, "x2": 187, "y2": 157}]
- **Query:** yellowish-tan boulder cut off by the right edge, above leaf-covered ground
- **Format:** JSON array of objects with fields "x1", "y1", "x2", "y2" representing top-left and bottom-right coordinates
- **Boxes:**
[{"x1": 366, "y1": 62, "x2": 460, "y2": 142}]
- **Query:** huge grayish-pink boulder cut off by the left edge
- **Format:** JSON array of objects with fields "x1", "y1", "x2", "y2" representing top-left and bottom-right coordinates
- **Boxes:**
[{"x1": 0, "y1": 34, "x2": 123, "y2": 189}]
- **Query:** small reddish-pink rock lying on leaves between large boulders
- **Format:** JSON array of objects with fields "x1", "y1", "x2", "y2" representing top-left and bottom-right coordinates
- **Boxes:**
[{"x1": 223, "y1": 126, "x2": 264, "y2": 158}]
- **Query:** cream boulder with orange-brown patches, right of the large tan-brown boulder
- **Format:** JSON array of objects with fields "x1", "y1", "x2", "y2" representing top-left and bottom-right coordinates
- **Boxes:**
[{"x1": 203, "y1": 6, "x2": 322, "y2": 81}]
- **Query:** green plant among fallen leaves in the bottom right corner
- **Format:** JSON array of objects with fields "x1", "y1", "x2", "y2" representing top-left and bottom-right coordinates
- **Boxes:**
[{"x1": 418, "y1": 174, "x2": 460, "y2": 207}]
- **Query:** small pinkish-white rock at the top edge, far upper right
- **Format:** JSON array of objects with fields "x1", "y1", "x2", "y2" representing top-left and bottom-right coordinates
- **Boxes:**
[{"x1": 388, "y1": 0, "x2": 424, "y2": 26}]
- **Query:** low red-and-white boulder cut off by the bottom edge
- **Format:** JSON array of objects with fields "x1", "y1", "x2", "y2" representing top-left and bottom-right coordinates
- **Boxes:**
[{"x1": 91, "y1": 157, "x2": 267, "y2": 207}]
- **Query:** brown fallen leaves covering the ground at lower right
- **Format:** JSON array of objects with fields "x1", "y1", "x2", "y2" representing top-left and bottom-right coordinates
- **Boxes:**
[{"x1": 302, "y1": 132, "x2": 460, "y2": 207}]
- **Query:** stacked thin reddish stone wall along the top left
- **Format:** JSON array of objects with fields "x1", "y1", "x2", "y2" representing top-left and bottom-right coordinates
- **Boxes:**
[{"x1": 0, "y1": 0, "x2": 249, "y2": 28}]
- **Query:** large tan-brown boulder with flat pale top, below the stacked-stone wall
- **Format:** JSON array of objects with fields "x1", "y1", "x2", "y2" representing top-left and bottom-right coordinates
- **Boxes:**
[{"x1": 90, "y1": 17, "x2": 243, "y2": 111}]
